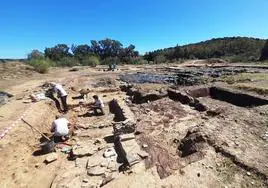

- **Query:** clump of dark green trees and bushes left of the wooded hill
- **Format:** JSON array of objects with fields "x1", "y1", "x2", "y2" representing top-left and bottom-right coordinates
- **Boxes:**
[{"x1": 28, "y1": 38, "x2": 142, "y2": 72}]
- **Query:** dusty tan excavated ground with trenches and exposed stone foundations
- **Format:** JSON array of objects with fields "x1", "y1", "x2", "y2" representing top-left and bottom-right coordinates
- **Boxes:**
[{"x1": 0, "y1": 61, "x2": 268, "y2": 188}]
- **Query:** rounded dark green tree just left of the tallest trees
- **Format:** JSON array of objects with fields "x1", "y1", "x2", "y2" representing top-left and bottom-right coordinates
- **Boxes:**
[{"x1": 45, "y1": 44, "x2": 71, "y2": 61}]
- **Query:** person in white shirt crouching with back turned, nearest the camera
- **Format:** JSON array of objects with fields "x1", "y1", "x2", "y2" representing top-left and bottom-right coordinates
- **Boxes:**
[{"x1": 51, "y1": 115, "x2": 71, "y2": 143}]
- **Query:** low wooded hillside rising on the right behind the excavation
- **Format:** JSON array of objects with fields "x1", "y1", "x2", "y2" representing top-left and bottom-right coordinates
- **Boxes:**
[{"x1": 144, "y1": 37, "x2": 265, "y2": 63}]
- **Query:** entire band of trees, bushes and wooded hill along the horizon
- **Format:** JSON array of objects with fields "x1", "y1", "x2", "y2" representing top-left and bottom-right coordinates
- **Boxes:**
[{"x1": 28, "y1": 37, "x2": 268, "y2": 73}]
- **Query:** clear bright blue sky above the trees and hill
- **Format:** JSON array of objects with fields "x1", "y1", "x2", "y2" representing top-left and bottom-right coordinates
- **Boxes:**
[{"x1": 0, "y1": 0, "x2": 268, "y2": 58}]
